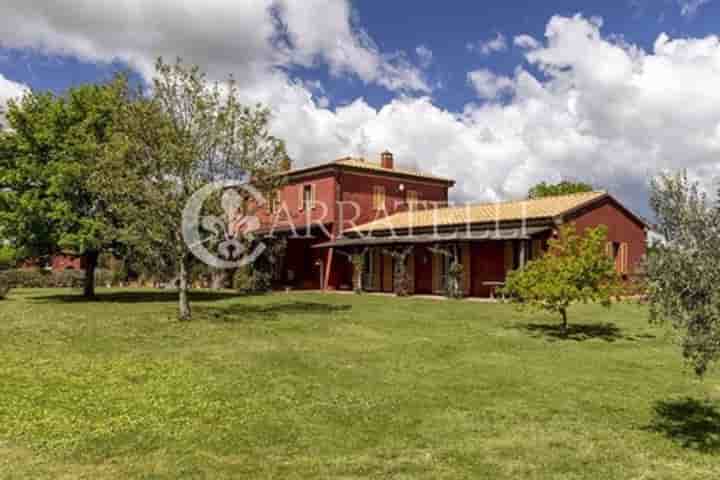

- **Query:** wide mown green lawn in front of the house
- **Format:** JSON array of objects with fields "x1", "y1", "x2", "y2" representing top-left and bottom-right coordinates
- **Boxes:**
[{"x1": 0, "y1": 290, "x2": 720, "y2": 480}]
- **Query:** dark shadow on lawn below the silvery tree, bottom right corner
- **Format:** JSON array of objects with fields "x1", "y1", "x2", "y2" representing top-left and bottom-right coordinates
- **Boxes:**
[{"x1": 648, "y1": 398, "x2": 720, "y2": 453}]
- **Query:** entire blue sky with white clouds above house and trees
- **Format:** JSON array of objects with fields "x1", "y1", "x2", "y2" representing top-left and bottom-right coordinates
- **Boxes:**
[{"x1": 0, "y1": 0, "x2": 720, "y2": 215}]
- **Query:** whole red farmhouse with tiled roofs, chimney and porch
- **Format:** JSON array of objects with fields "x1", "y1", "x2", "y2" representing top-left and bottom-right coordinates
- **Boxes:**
[{"x1": 261, "y1": 152, "x2": 646, "y2": 297}]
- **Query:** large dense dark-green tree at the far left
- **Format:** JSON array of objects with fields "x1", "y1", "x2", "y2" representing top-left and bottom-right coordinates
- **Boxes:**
[{"x1": 0, "y1": 76, "x2": 128, "y2": 297}]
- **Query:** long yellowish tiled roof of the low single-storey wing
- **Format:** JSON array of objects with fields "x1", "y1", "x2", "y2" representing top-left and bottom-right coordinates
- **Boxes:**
[{"x1": 351, "y1": 192, "x2": 607, "y2": 233}]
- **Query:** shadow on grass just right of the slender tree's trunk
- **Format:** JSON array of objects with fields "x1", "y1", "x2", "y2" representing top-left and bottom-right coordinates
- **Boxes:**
[{"x1": 193, "y1": 302, "x2": 352, "y2": 323}]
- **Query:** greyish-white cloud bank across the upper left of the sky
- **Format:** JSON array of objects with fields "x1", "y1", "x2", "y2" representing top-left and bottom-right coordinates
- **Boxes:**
[{"x1": 0, "y1": 0, "x2": 430, "y2": 92}]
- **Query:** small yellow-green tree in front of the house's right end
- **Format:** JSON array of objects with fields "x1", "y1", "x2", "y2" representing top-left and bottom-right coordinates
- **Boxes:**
[{"x1": 503, "y1": 224, "x2": 620, "y2": 331}]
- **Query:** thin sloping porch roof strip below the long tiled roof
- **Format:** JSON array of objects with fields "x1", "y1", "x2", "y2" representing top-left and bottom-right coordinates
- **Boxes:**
[{"x1": 313, "y1": 227, "x2": 550, "y2": 248}]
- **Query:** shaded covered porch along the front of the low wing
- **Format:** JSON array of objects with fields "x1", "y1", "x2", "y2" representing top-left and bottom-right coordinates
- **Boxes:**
[{"x1": 315, "y1": 227, "x2": 551, "y2": 298}]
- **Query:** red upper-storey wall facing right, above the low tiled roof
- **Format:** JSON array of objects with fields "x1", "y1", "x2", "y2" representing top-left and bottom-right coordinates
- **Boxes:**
[{"x1": 339, "y1": 172, "x2": 448, "y2": 229}]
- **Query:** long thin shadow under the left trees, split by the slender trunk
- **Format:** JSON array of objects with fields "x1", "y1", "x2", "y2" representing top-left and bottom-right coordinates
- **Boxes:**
[{"x1": 33, "y1": 290, "x2": 239, "y2": 303}]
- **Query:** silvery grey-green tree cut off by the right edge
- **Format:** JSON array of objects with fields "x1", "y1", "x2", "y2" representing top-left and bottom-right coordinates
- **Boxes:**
[{"x1": 646, "y1": 173, "x2": 720, "y2": 376}]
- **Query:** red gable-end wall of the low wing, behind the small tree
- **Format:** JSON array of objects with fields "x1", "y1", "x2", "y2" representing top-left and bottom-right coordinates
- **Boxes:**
[{"x1": 568, "y1": 200, "x2": 646, "y2": 274}]
